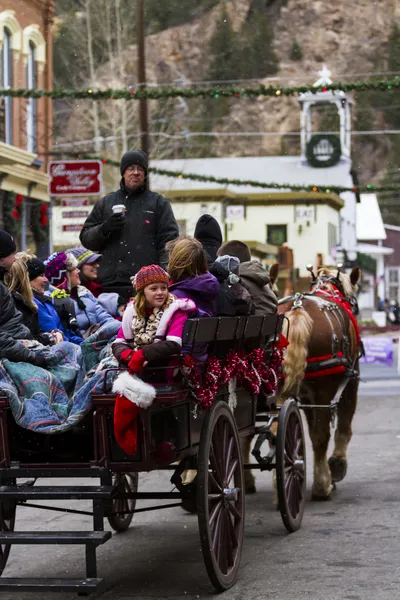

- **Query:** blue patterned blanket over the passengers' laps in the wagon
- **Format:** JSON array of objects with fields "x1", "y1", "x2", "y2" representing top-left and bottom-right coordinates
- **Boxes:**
[{"x1": 0, "y1": 321, "x2": 120, "y2": 434}]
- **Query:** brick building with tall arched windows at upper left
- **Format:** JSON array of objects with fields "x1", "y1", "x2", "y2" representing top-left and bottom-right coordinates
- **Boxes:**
[{"x1": 0, "y1": 0, "x2": 54, "y2": 253}]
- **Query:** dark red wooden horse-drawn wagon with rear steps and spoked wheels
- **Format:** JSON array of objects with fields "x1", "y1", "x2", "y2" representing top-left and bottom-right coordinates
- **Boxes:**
[{"x1": 0, "y1": 315, "x2": 306, "y2": 594}]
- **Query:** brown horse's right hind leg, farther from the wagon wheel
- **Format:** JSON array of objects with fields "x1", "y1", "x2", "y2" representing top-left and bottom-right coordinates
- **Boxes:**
[{"x1": 329, "y1": 379, "x2": 358, "y2": 481}]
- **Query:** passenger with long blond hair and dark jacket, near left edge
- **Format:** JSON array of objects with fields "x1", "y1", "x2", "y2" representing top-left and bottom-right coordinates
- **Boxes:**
[{"x1": 5, "y1": 252, "x2": 64, "y2": 346}]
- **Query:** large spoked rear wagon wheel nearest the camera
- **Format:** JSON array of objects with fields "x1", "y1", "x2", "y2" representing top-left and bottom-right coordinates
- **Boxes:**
[{"x1": 197, "y1": 401, "x2": 244, "y2": 591}]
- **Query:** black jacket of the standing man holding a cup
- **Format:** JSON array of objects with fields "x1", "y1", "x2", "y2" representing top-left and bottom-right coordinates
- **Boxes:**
[{"x1": 80, "y1": 180, "x2": 179, "y2": 286}]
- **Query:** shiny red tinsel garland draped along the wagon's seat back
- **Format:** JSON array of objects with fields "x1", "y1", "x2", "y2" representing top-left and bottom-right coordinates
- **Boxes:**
[{"x1": 182, "y1": 346, "x2": 283, "y2": 408}]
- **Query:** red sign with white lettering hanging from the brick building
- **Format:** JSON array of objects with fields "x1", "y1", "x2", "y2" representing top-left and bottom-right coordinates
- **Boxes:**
[{"x1": 48, "y1": 160, "x2": 103, "y2": 196}]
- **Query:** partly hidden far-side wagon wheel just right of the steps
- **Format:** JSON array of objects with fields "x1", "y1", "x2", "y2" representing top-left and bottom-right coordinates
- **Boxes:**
[{"x1": 107, "y1": 473, "x2": 139, "y2": 531}]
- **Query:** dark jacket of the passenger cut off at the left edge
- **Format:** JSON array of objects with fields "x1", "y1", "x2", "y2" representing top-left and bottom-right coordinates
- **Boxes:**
[{"x1": 0, "y1": 269, "x2": 35, "y2": 363}]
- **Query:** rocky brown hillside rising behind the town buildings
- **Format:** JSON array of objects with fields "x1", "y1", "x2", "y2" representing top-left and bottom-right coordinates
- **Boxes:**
[{"x1": 58, "y1": 0, "x2": 400, "y2": 192}]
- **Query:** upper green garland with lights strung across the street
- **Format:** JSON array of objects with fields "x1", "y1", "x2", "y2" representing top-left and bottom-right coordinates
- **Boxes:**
[{"x1": 0, "y1": 77, "x2": 400, "y2": 100}]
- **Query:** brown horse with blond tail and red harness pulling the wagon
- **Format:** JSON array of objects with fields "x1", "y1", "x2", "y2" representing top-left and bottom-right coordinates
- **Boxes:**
[{"x1": 278, "y1": 267, "x2": 360, "y2": 500}]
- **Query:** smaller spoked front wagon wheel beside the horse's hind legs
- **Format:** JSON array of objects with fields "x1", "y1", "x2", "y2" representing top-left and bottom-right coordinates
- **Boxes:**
[{"x1": 276, "y1": 398, "x2": 306, "y2": 532}]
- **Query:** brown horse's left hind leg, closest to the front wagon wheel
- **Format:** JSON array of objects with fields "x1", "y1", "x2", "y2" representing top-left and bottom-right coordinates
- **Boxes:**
[{"x1": 305, "y1": 402, "x2": 333, "y2": 500}]
